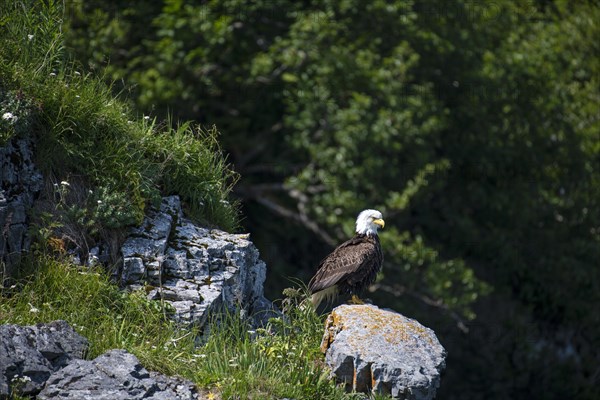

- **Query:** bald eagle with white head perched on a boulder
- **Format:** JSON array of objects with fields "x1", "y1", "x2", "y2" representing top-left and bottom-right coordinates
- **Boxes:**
[{"x1": 308, "y1": 210, "x2": 385, "y2": 308}]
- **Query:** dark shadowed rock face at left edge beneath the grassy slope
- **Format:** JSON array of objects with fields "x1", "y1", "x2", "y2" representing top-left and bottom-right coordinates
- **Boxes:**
[{"x1": 0, "y1": 139, "x2": 43, "y2": 284}]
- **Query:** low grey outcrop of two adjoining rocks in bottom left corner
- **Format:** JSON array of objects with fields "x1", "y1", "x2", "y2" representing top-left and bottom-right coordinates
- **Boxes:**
[{"x1": 0, "y1": 321, "x2": 199, "y2": 400}]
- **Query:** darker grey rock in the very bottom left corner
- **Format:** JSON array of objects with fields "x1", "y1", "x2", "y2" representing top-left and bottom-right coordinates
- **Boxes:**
[{"x1": 0, "y1": 321, "x2": 88, "y2": 397}]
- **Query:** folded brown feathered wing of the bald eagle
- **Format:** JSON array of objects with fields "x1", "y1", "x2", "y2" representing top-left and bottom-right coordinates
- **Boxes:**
[{"x1": 308, "y1": 238, "x2": 377, "y2": 293}]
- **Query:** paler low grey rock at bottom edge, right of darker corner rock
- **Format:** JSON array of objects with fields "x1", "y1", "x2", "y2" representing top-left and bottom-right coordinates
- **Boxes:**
[{"x1": 37, "y1": 350, "x2": 198, "y2": 400}]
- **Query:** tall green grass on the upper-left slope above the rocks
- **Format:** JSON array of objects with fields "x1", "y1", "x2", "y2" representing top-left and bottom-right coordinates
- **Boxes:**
[{"x1": 0, "y1": 1, "x2": 238, "y2": 230}]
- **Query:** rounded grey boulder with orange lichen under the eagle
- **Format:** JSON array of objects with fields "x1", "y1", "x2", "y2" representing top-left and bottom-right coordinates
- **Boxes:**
[{"x1": 321, "y1": 304, "x2": 446, "y2": 400}]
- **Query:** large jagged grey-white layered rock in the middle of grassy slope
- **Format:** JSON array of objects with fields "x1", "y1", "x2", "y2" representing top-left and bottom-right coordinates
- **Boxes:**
[{"x1": 120, "y1": 196, "x2": 276, "y2": 326}]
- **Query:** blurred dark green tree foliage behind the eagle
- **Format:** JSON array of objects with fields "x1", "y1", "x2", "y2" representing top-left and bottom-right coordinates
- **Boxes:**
[{"x1": 64, "y1": 0, "x2": 600, "y2": 399}]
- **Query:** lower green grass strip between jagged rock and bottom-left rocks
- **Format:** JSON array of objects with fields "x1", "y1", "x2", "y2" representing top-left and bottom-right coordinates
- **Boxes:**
[{"x1": 0, "y1": 257, "x2": 366, "y2": 399}]
